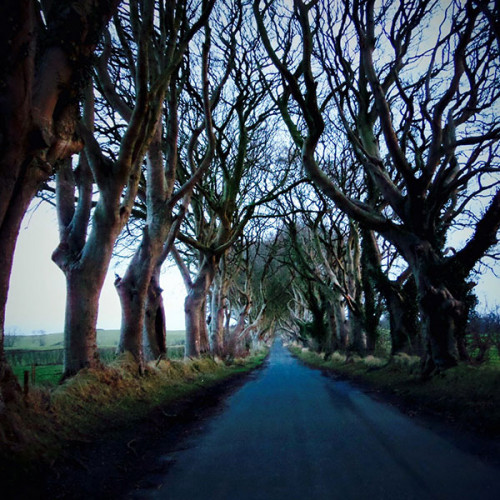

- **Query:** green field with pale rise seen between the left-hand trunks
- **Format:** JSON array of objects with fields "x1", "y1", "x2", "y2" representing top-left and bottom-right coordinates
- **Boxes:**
[{"x1": 5, "y1": 330, "x2": 186, "y2": 385}]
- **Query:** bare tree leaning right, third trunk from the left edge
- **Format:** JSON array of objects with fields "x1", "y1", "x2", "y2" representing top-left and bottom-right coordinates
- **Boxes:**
[{"x1": 110, "y1": 1, "x2": 218, "y2": 363}]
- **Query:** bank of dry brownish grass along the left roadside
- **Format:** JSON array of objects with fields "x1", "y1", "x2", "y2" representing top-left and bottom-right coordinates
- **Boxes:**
[{"x1": 0, "y1": 351, "x2": 267, "y2": 477}]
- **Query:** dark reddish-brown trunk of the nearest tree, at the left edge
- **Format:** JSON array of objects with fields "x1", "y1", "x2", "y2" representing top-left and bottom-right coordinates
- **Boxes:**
[{"x1": 0, "y1": 0, "x2": 119, "y2": 396}]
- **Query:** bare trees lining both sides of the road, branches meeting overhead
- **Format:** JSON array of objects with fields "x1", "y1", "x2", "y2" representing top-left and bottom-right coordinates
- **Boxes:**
[{"x1": 0, "y1": 0, "x2": 500, "y2": 401}]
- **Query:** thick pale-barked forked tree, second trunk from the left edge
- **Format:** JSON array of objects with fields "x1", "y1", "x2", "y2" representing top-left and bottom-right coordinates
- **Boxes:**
[{"x1": 53, "y1": 0, "x2": 188, "y2": 376}]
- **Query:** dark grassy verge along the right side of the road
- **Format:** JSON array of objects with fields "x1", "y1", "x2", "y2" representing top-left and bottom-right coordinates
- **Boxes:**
[{"x1": 290, "y1": 346, "x2": 500, "y2": 437}]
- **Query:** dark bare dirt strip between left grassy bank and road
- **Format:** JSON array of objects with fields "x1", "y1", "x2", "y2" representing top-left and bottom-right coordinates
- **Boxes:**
[{"x1": 2, "y1": 367, "x2": 268, "y2": 500}]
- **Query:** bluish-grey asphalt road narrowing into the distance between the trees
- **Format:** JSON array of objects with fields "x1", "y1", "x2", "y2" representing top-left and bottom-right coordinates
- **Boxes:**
[{"x1": 128, "y1": 344, "x2": 500, "y2": 500}]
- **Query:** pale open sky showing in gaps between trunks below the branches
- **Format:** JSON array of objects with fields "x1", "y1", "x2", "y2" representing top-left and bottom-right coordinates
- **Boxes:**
[{"x1": 5, "y1": 200, "x2": 500, "y2": 334}]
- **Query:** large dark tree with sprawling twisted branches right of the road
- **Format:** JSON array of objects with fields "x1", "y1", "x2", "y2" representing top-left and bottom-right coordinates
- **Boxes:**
[{"x1": 253, "y1": 0, "x2": 500, "y2": 373}]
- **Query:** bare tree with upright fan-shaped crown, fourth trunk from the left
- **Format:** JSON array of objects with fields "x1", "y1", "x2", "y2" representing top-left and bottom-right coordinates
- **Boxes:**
[{"x1": 174, "y1": 2, "x2": 288, "y2": 356}]
